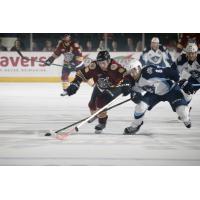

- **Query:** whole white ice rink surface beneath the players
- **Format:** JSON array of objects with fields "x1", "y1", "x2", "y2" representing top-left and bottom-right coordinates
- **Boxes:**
[{"x1": 0, "y1": 83, "x2": 200, "y2": 166}]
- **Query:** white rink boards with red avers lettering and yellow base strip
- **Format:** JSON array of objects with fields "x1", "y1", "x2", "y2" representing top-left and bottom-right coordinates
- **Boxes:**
[{"x1": 0, "y1": 52, "x2": 141, "y2": 82}]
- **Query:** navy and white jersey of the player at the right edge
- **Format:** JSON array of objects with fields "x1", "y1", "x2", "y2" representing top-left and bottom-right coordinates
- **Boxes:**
[{"x1": 172, "y1": 53, "x2": 200, "y2": 83}]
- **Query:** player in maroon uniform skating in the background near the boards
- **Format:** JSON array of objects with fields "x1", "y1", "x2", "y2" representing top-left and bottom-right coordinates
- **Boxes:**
[{"x1": 45, "y1": 34, "x2": 84, "y2": 95}]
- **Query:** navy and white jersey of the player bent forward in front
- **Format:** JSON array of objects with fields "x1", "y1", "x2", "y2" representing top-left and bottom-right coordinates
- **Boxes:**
[{"x1": 134, "y1": 65, "x2": 179, "y2": 96}]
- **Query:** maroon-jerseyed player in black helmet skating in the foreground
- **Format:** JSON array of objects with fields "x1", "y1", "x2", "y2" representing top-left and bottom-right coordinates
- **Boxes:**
[{"x1": 65, "y1": 51, "x2": 129, "y2": 134}]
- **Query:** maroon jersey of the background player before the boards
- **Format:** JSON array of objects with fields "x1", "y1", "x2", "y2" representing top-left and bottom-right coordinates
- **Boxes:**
[{"x1": 53, "y1": 40, "x2": 83, "y2": 67}]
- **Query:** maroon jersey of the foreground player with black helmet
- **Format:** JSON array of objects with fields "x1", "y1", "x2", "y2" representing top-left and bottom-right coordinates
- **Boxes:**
[{"x1": 74, "y1": 59, "x2": 126, "y2": 89}]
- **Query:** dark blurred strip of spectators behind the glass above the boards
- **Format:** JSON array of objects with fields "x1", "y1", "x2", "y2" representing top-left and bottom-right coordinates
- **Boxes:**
[{"x1": 0, "y1": 33, "x2": 200, "y2": 52}]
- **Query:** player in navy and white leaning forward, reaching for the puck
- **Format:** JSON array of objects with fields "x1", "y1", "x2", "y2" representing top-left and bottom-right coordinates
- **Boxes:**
[{"x1": 124, "y1": 61, "x2": 191, "y2": 135}]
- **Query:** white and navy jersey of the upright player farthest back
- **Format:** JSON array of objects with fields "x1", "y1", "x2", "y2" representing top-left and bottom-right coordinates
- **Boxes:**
[{"x1": 140, "y1": 46, "x2": 173, "y2": 67}]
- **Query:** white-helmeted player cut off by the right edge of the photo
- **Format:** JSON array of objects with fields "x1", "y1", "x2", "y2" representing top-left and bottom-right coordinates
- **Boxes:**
[{"x1": 172, "y1": 43, "x2": 200, "y2": 104}]
